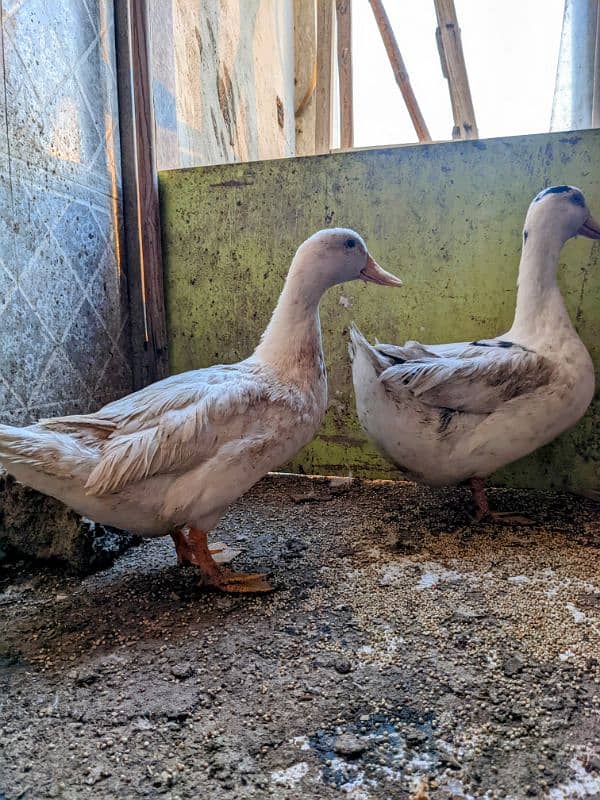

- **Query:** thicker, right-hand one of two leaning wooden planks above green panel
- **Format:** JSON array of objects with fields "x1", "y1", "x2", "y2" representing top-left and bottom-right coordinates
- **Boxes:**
[{"x1": 434, "y1": 0, "x2": 479, "y2": 139}]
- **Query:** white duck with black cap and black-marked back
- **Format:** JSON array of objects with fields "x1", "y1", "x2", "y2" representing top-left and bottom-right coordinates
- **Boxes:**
[{"x1": 350, "y1": 186, "x2": 600, "y2": 523}]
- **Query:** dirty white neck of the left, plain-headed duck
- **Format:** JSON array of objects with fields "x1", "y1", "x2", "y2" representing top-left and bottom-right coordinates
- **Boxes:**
[{"x1": 254, "y1": 269, "x2": 324, "y2": 383}]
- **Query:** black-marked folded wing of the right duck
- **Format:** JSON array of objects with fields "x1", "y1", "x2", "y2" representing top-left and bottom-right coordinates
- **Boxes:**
[{"x1": 375, "y1": 339, "x2": 554, "y2": 414}]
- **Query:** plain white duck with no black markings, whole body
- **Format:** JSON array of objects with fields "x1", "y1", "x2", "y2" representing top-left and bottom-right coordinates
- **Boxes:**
[{"x1": 0, "y1": 228, "x2": 401, "y2": 592}]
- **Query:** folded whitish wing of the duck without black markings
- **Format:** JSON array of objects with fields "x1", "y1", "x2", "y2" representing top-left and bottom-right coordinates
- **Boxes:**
[{"x1": 41, "y1": 361, "x2": 290, "y2": 495}]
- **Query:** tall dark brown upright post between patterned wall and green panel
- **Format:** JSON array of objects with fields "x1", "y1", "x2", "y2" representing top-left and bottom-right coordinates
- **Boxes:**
[{"x1": 115, "y1": 0, "x2": 169, "y2": 388}]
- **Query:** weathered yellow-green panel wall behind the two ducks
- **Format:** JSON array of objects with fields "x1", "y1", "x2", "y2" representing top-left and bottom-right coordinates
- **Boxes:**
[{"x1": 160, "y1": 131, "x2": 600, "y2": 491}]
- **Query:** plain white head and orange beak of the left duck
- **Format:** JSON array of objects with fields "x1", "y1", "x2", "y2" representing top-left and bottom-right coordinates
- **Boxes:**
[{"x1": 290, "y1": 228, "x2": 402, "y2": 293}]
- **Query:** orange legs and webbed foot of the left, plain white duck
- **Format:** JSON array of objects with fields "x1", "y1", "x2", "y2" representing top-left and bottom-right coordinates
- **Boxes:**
[{"x1": 171, "y1": 528, "x2": 273, "y2": 593}]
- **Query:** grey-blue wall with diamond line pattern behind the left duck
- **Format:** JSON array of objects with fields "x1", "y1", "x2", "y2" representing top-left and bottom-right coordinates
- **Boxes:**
[{"x1": 0, "y1": 0, "x2": 131, "y2": 424}]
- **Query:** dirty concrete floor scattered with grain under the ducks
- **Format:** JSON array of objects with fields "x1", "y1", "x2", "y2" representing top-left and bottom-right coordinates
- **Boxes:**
[{"x1": 0, "y1": 477, "x2": 600, "y2": 800}]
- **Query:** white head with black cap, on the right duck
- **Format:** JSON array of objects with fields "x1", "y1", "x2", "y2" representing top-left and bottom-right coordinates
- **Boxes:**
[{"x1": 523, "y1": 186, "x2": 600, "y2": 242}]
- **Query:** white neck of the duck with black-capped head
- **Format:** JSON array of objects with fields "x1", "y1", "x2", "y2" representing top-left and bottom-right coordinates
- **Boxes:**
[{"x1": 510, "y1": 229, "x2": 572, "y2": 340}]
